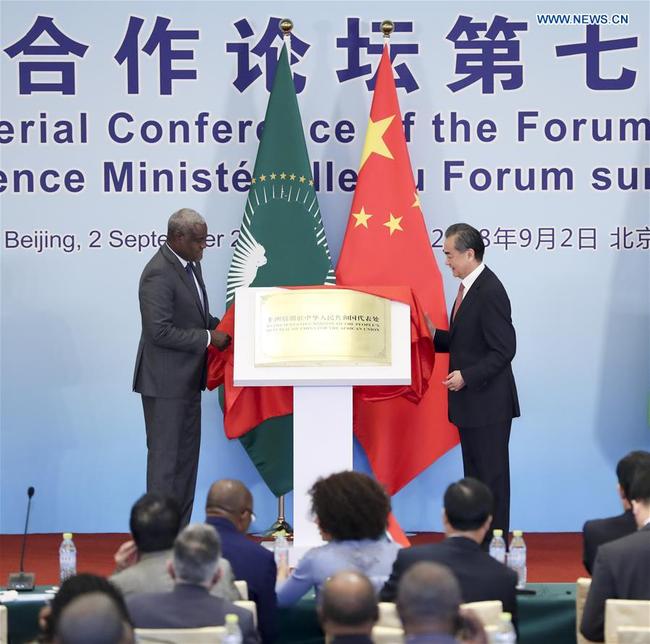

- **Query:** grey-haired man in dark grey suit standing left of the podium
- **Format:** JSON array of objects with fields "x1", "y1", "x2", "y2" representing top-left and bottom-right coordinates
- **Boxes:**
[{"x1": 133, "y1": 208, "x2": 230, "y2": 525}]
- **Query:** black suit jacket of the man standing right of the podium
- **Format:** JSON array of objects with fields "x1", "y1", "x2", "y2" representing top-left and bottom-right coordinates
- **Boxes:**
[{"x1": 434, "y1": 266, "x2": 519, "y2": 427}]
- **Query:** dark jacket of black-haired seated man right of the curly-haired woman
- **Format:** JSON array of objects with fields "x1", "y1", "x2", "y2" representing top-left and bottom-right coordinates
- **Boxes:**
[{"x1": 379, "y1": 537, "x2": 517, "y2": 621}]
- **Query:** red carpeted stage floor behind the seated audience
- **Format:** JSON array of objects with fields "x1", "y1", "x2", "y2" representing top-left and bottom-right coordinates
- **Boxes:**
[{"x1": 0, "y1": 532, "x2": 586, "y2": 585}]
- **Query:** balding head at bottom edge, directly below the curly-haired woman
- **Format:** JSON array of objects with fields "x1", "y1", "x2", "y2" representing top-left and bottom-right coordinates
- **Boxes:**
[{"x1": 317, "y1": 570, "x2": 379, "y2": 644}]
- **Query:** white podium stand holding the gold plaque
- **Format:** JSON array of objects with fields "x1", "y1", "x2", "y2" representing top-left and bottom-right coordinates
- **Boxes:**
[{"x1": 234, "y1": 288, "x2": 411, "y2": 565}]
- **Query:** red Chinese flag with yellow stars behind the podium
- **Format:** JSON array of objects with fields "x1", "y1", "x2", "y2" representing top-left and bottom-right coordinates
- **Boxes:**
[{"x1": 336, "y1": 47, "x2": 458, "y2": 494}]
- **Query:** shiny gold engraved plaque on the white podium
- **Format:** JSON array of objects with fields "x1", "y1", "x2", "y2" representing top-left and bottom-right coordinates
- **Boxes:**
[{"x1": 255, "y1": 289, "x2": 391, "y2": 367}]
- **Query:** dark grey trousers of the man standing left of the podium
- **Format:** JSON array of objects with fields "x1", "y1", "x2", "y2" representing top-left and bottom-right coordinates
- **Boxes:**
[{"x1": 142, "y1": 392, "x2": 201, "y2": 526}]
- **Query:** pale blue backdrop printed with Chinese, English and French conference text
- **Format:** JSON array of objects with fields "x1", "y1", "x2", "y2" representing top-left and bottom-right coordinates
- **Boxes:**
[{"x1": 0, "y1": 0, "x2": 650, "y2": 533}]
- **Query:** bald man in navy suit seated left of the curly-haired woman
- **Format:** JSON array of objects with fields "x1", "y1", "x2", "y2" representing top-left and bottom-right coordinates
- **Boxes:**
[{"x1": 205, "y1": 479, "x2": 277, "y2": 644}]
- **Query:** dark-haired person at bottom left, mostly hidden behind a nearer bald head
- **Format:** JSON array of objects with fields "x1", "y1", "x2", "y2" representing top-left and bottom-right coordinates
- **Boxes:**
[{"x1": 37, "y1": 573, "x2": 131, "y2": 644}]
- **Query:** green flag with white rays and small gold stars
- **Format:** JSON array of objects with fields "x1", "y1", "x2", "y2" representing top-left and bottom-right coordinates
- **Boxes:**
[{"x1": 226, "y1": 46, "x2": 335, "y2": 496}]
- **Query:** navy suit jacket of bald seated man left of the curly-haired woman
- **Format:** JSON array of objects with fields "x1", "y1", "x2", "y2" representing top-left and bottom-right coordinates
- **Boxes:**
[{"x1": 205, "y1": 517, "x2": 277, "y2": 644}]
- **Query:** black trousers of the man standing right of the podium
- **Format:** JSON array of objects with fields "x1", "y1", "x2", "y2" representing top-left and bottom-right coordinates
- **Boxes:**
[{"x1": 458, "y1": 419, "x2": 512, "y2": 541}]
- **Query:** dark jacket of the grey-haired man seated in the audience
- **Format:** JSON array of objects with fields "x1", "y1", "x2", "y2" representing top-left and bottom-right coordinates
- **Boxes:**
[{"x1": 126, "y1": 584, "x2": 260, "y2": 644}]
